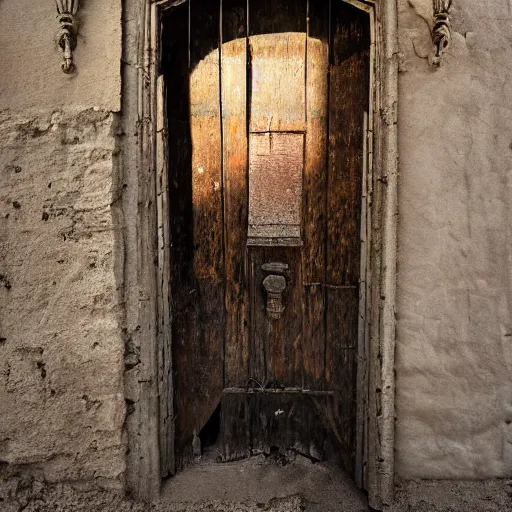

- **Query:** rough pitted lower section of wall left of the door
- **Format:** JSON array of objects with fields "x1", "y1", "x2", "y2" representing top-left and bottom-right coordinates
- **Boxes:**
[{"x1": 0, "y1": 109, "x2": 125, "y2": 487}]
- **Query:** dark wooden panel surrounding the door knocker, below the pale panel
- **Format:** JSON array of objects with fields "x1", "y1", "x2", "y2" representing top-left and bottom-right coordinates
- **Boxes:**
[{"x1": 249, "y1": 247, "x2": 303, "y2": 386}]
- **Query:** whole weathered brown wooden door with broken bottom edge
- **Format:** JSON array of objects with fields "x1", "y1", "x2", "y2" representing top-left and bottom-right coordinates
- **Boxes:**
[{"x1": 162, "y1": 0, "x2": 370, "y2": 471}]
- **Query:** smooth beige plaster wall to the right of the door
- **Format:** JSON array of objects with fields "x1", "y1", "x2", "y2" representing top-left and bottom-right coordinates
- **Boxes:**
[{"x1": 396, "y1": 0, "x2": 512, "y2": 478}]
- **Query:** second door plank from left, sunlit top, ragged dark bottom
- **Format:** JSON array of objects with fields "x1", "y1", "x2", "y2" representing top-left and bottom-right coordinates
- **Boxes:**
[{"x1": 186, "y1": 1, "x2": 225, "y2": 439}]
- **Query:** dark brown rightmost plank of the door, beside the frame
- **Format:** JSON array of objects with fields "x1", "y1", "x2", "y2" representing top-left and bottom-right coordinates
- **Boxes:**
[{"x1": 326, "y1": 2, "x2": 370, "y2": 471}]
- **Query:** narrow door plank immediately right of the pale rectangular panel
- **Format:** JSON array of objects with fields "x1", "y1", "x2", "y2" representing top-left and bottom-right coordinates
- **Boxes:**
[{"x1": 302, "y1": 0, "x2": 329, "y2": 389}]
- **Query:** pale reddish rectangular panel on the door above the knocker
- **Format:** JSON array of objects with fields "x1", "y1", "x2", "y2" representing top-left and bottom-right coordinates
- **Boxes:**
[{"x1": 248, "y1": 133, "x2": 304, "y2": 244}]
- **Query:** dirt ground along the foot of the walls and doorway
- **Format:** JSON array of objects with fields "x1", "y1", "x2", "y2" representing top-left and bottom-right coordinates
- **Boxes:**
[{"x1": 0, "y1": 456, "x2": 512, "y2": 512}]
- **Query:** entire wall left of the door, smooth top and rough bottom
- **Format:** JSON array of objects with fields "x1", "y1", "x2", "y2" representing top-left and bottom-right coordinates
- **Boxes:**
[{"x1": 0, "y1": 0, "x2": 126, "y2": 494}]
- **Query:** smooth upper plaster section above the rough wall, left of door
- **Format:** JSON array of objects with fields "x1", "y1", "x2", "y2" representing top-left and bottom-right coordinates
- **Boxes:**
[{"x1": 0, "y1": 0, "x2": 121, "y2": 111}]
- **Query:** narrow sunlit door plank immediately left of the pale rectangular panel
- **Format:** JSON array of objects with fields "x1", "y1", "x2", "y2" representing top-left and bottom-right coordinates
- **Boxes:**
[{"x1": 221, "y1": 0, "x2": 249, "y2": 386}]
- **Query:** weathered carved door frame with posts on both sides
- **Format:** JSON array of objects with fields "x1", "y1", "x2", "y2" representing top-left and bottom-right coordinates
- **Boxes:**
[{"x1": 120, "y1": 0, "x2": 398, "y2": 510}]
